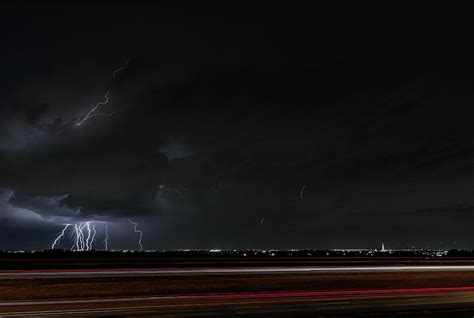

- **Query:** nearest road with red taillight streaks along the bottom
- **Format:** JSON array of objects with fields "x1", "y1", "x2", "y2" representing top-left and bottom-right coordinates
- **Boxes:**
[{"x1": 0, "y1": 287, "x2": 474, "y2": 317}]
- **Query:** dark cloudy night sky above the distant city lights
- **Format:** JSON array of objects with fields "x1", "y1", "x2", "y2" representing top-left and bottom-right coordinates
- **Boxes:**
[{"x1": 0, "y1": 1, "x2": 474, "y2": 249}]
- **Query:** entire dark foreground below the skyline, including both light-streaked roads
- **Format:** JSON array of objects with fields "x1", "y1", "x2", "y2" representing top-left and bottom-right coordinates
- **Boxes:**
[{"x1": 0, "y1": 258, "x2": 474, "y2": 317}]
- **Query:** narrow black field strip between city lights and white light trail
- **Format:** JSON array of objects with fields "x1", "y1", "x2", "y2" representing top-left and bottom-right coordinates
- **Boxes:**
[{"x1": 0, "y1": 253, "x2": 474, "y2": 271}]
